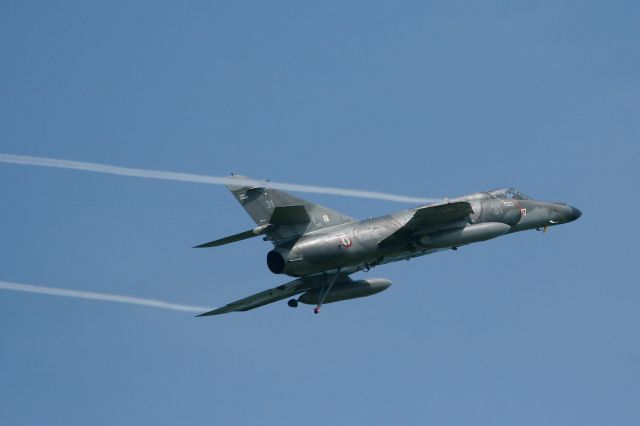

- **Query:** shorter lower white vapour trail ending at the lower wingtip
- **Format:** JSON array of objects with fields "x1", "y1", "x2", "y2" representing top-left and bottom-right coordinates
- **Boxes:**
[{"x1": 0, "y1": 281, "x2": 211, "y2": 312}]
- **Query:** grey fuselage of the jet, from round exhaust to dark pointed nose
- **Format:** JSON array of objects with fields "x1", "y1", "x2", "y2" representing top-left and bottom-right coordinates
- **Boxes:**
[{"x1": 267, "y1": 189, "x2": 581, "y2": 277}]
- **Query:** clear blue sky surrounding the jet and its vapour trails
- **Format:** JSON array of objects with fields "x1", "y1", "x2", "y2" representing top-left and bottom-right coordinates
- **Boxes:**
[{"x1": 0, "y1": 0, "x2": 640, "y2": 425}]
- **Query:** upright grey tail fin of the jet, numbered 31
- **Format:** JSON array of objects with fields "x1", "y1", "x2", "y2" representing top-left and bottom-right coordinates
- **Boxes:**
[{"x1": 227, "y1": 175, "x2": 354, "y2": 232}]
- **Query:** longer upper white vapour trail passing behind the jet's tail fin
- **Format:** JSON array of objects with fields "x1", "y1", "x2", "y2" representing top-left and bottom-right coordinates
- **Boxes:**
[{"x1": 0, "y1": 153, "x2": 441, "y2": 204}]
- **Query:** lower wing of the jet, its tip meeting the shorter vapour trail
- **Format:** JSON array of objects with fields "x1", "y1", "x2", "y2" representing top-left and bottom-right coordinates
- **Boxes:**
[{"x1": 196, "y1": 274, "x2": 350, "y2": 317}]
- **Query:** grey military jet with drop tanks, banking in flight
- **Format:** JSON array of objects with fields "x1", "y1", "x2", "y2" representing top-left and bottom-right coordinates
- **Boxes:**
[{"x1": 196, "y1": 175, "x2": 582, "y2": 316}]
